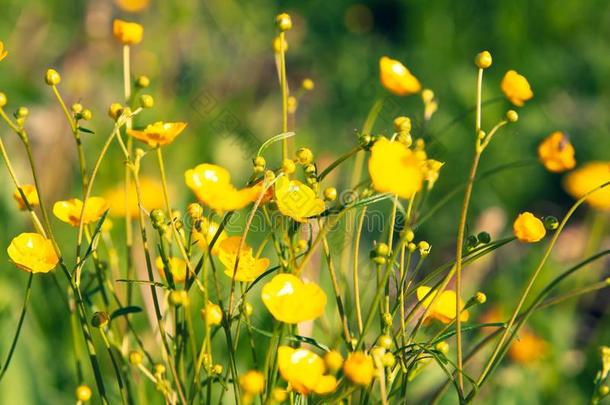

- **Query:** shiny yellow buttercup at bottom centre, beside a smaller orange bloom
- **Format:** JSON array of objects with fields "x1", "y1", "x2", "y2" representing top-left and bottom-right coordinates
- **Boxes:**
[{"x1": 277, "y1": 346, "x2": 337, "y2": 395}]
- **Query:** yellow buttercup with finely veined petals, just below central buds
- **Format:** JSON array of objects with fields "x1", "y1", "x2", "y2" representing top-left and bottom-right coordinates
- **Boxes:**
[{"x1": 274, "y1": 176, "x2": 325, "y2": 222}]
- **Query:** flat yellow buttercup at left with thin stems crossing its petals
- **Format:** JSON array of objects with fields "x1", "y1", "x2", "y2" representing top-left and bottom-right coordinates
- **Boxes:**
[{"x1": 105, "y1": 177, "x2": 165, "y2": 218}]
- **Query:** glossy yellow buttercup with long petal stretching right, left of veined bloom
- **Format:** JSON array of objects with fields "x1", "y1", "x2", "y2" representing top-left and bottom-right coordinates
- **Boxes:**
[{"x1": 184, "y1": 163, "x2": 260, "y2": 212}]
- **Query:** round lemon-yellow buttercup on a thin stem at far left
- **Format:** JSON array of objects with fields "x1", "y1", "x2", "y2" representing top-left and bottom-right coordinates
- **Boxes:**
[{"x1": 7, "y1": 233, "x2": 59, "y2": 273}]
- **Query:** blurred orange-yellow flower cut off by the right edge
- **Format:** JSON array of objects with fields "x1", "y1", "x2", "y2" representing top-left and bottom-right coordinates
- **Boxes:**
[{"x1": 563, "y1": 161, "x2": 610, "y2": 211}]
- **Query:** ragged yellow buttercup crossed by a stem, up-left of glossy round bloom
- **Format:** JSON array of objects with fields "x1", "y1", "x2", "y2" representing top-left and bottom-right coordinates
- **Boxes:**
[{"x1": 218, "y1": 236, "x2": 269, "y2": 282}]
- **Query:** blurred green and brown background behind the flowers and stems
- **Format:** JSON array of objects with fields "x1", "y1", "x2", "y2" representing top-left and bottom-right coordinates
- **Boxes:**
[{"x1": 0, "y1": 0, "x2": 610, "y2": 404}]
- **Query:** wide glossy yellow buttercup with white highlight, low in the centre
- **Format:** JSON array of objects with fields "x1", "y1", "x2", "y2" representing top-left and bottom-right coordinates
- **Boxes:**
[{"x1": 261, "y1": 273, "x2": 326, "y2": 323}]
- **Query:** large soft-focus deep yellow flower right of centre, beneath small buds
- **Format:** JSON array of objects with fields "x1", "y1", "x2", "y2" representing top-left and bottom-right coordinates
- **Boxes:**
[{"x1": 369, "y1": 137, "x2": 426, "y2": 199}]
